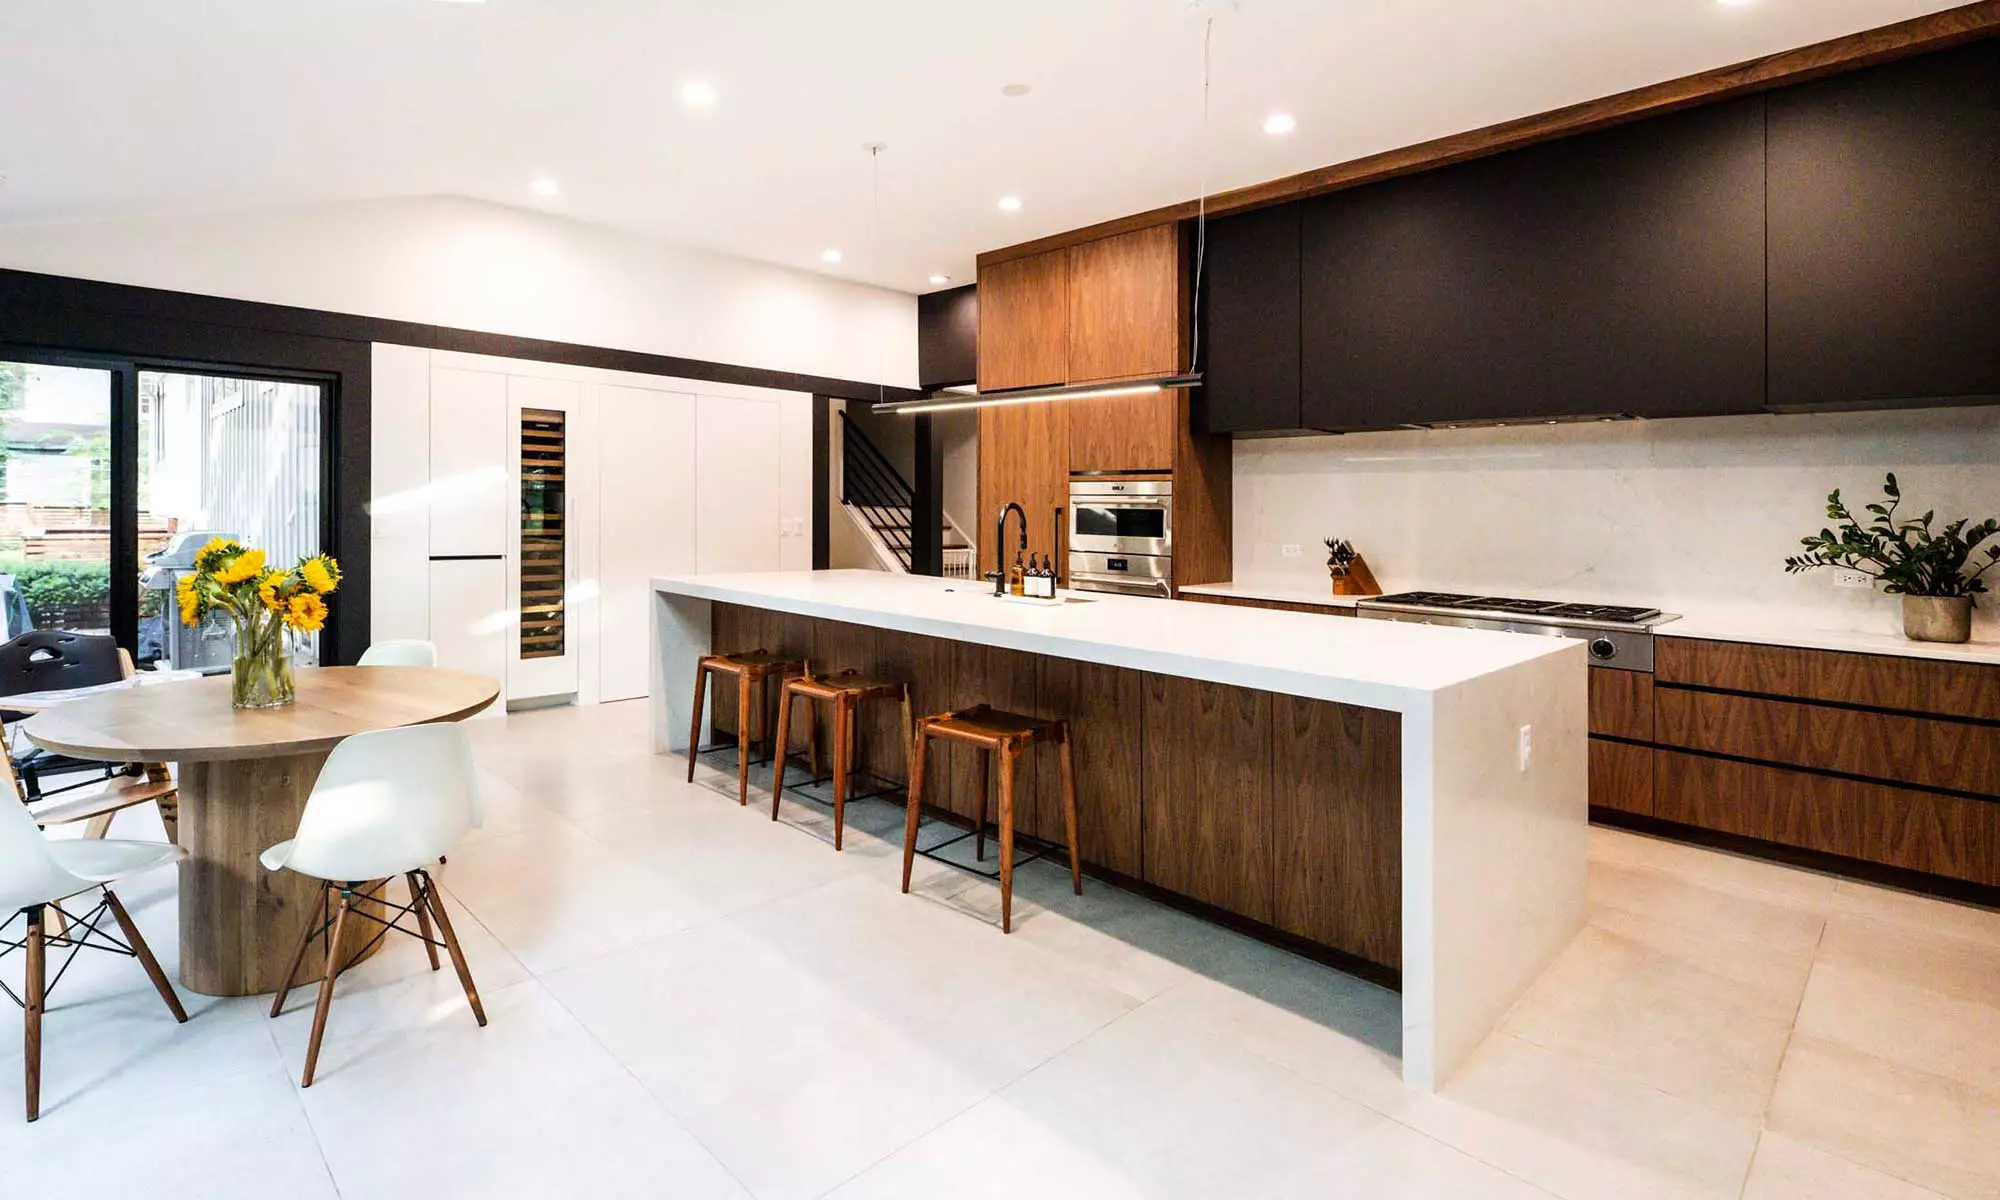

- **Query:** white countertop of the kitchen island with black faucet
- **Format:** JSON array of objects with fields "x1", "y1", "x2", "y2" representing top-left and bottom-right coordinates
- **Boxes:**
[{"x1": 652, "y1": 570, "x2": 1586, "y2": 712}]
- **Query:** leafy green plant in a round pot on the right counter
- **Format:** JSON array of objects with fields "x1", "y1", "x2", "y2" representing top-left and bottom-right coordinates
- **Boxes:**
[{"x1": 1784, "y1": 472, "x2": 2000, "y2": 642}]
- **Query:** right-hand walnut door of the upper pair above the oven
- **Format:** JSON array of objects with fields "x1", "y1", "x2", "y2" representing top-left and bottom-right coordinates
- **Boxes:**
[{"x1": 1068, "y1": 224, "x2": 1186, "y2": 384}]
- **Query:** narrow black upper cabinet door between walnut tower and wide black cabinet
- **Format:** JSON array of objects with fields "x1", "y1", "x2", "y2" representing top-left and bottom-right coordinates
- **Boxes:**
[{"x1": 1194, "y1": 204, "x2": 1304, "y2": 434}]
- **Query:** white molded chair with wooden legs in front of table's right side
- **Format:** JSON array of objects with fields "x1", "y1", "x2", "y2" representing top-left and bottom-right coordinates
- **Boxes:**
[{"x1": 262, "y1": 724, "x2": 486, "y2": 1088}]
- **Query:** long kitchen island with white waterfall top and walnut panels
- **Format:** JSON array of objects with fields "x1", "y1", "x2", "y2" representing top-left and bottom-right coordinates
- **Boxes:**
[{"x1": 650, "y1": 570, "x2": 1588, "y2": 1090}]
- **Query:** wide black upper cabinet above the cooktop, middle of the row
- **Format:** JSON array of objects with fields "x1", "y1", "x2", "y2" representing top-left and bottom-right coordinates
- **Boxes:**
[{"x1": 1296, "y1": 96, "x2": 1764, "y2": 430}]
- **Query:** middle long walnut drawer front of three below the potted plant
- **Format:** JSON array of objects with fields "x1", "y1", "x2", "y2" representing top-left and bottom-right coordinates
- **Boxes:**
[{"x1": 1654, "y1": 688, "x2": 2000, "y2": 796}]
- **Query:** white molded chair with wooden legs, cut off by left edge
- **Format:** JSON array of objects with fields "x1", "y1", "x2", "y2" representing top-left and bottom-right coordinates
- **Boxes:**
[{"x1": 0, "y1": 760, "x2": 188, "y2": 1120}]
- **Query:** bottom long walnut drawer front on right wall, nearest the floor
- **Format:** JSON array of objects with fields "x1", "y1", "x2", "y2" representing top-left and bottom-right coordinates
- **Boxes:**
[{"x1": 1654, "y1": 750, "x2": 2000, "y2": 884}]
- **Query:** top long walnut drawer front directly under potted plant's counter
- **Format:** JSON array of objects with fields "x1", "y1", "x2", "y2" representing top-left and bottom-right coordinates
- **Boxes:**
[{"x1": 1652, "y1": 638, "x2": 2000, "y2": 720}]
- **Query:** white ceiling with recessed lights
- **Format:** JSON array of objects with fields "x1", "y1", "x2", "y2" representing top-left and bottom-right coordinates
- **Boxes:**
[{"x1": 0, "y1": 0, "x2": 1952, "y2": 292}]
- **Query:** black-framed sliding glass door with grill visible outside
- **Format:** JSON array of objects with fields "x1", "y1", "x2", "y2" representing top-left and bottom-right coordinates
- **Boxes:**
[{"x1": 0, "y1": 360, "x2": 328, "y2": 670}]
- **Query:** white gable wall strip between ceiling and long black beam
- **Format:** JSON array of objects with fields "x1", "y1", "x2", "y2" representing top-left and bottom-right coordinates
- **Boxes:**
[{"x1": 0, "y1": 196, "x2": 916, "y2": 386}]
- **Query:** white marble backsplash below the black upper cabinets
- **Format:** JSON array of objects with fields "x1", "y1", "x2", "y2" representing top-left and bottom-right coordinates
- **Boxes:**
[{"x1": 1234, "y1": 408, "x2": 2000, "y2": 638}]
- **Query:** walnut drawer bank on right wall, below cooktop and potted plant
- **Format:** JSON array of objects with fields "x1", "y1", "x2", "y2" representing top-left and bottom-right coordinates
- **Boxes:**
[{"x1": 1590, "y1": 636, "x2": 2000, "y2": 904}]
